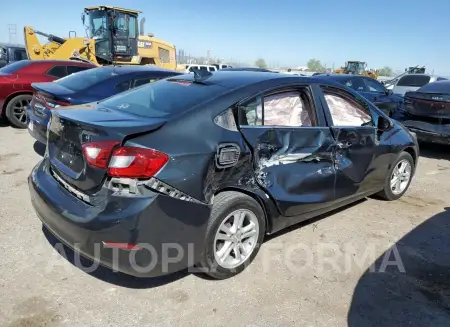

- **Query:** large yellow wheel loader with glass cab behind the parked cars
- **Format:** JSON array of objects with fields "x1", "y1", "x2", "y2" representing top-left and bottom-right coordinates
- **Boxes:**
[{"x1": 24, "y1": 6, "x2": 177, "y2": 69}]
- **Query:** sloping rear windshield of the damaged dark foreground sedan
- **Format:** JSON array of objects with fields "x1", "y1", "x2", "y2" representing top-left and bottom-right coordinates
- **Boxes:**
[{"x1": 100, "y1": 79, "x2": 227, "y2": 117}]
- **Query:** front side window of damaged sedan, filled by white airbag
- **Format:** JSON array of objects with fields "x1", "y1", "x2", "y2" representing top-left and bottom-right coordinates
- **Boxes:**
[{"x1": 324, "y1": 91, "x2": 372, "y2": 127}]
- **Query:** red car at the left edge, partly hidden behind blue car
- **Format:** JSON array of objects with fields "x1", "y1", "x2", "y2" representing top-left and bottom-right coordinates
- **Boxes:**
[{"x1": 0, "y1": 60, "x2": 96, "y2": 128}]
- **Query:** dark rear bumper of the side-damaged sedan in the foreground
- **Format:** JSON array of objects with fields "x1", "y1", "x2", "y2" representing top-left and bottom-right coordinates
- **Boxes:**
[{"x1": 28, "y1": 161, "x2": 210, "y2": 277}]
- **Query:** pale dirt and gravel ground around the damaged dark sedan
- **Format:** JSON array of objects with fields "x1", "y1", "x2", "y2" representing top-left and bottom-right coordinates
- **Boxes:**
[{"x1": 0, "y1": 127, "x2": 450, "y2": 327}]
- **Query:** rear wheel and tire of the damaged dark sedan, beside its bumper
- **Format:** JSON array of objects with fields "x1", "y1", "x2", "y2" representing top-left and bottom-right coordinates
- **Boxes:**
[{"x1": 199, "y1": 191, "x2": 266, "y2": 279}]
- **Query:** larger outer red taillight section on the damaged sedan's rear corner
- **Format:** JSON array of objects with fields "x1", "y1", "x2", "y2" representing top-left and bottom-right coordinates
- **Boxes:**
[{"x1": 108, "y1": 146, "x2": 169, "y2": 178}]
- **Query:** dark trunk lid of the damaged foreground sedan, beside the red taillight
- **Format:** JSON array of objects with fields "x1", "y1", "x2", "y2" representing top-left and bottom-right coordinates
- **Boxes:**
[{"x1": 47, "y1": 104, "x2": 166, "y2": 193}]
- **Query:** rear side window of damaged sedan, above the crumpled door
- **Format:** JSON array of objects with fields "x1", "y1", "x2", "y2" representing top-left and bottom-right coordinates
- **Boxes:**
[{"x1": 239, "y1": 90, "x2": 316, "y2": 127}]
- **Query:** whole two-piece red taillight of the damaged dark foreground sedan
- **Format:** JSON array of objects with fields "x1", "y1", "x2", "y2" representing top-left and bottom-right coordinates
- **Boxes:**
[{"x1": 83, "y1": 141, "x2": 169, "y2": 178}]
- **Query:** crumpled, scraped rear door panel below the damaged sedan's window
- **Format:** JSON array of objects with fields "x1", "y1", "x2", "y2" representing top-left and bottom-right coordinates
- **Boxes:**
[{"x1": 241, "y1": 127, "x2": 335, "y2": 216}]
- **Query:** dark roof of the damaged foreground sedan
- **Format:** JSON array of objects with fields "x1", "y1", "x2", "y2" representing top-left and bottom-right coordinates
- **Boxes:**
[{"x1": 175, "y1": 69, "x2": 318, "y2": 88}]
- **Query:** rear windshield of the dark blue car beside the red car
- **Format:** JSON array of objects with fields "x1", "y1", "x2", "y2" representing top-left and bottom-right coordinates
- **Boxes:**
[{"x1": 54, "y1": 67, "x2": 118, "y2": 91}]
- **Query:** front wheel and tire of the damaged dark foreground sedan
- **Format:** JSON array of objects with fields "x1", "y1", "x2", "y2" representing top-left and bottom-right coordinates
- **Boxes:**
[{"x1": 377, "y1": 151, "x2": 414, "y2": 201}]
